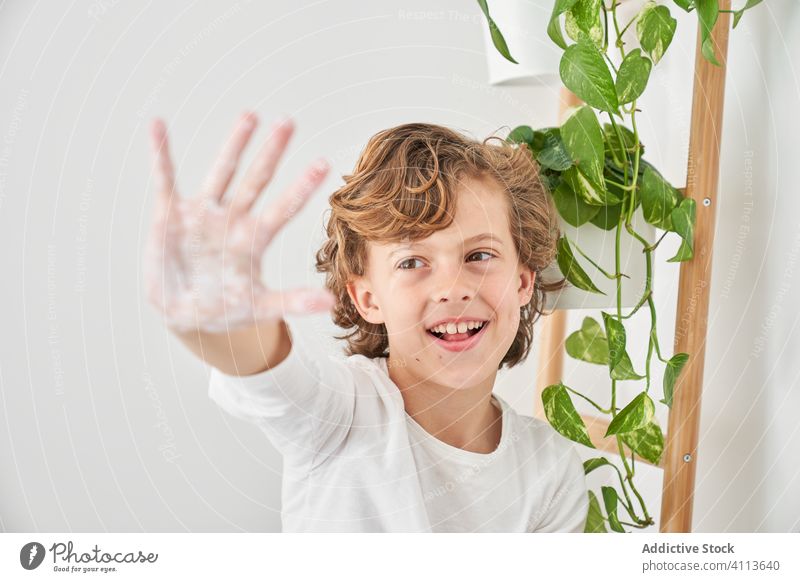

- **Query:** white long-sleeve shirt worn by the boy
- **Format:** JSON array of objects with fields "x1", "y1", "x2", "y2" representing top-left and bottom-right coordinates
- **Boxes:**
[{"x1": 209, "y1": 322, "x2": 589, "y2": 532}]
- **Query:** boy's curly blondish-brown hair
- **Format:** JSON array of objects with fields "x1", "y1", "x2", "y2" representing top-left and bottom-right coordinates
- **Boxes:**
[{"x1": 316, "y1": 123, "x2": 564, "y2": 369}]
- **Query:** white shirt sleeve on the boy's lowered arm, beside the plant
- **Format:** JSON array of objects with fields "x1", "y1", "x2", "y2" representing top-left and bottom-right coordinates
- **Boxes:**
[{"x1": 535, "y1": 437, "x2": 589, "y2": 533}]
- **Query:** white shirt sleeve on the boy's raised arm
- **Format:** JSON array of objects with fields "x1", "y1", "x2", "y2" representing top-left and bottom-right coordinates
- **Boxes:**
[{"x1": 209, "y1": 320, "x2": 355, "y2": 470}]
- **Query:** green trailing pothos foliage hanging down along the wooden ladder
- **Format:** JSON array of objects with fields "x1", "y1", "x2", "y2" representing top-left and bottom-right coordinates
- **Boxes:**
[{"x1": 478, "y1": 0, "x2": 762, "y2": 532}]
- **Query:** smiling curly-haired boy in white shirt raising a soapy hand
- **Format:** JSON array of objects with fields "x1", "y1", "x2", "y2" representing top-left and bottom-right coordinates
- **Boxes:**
[{"x1": 145, "y1": 113, "x2": 588, "y2": 532}]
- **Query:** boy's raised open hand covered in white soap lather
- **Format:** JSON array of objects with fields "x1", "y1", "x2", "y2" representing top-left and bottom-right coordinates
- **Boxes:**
[{"x1": 143, "y1": 113, "x2": 334, "y2": 333}]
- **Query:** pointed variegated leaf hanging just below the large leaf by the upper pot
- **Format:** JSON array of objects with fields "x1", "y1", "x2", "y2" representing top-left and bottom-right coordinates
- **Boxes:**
[{"x1": 561, "y1": 105, "x2": 605, "y2": 192}]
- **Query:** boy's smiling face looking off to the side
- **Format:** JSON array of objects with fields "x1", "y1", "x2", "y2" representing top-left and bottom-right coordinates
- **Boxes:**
[{"x1": 347, "y1": 178, "x2": 535, "y2": 389}]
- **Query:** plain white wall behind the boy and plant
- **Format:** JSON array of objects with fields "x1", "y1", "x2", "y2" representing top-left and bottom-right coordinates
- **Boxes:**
[{"x1": 0, "y1": 0, "x2": 800, "y2": 532}]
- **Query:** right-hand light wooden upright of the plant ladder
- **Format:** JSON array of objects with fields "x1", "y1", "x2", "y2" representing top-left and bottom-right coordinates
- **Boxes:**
[{"x1": 660, "y1": 0, "x2": 731, "y2": 533}]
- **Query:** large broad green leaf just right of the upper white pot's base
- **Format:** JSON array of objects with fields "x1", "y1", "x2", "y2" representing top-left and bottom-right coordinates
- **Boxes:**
[{"x1": 559, "y1": 41, "x2": 619, "y2": 115}]
